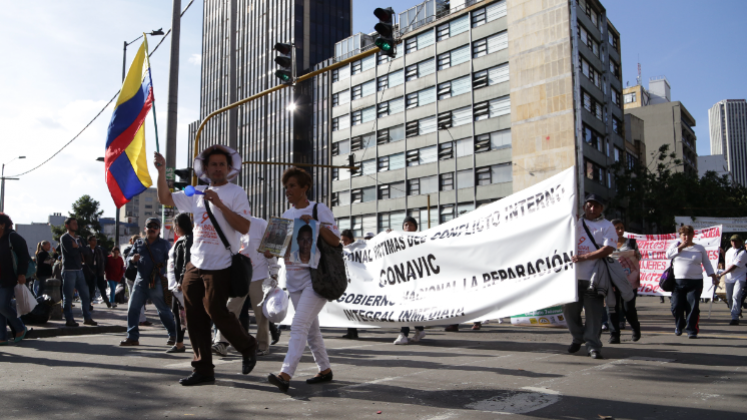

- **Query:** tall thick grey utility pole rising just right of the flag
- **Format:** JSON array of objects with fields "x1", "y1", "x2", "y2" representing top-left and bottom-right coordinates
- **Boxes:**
[{"x1": 161, "y1": 0, "x2": 182, "y2": 238}]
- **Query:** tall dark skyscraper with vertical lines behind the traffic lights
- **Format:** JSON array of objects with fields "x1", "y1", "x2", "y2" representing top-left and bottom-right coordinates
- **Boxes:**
[{"x1": 188, "y1": 0, "x2": 352, "y2": 218}]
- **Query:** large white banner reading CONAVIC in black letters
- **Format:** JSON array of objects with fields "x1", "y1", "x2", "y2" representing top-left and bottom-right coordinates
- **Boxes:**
[{"x1": 285, "y1": 168, "x2": 577, "y2": 328}]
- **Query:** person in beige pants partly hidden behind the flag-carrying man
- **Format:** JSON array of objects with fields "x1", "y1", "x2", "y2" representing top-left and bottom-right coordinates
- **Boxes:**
[{"x1": 213, "y1": 216, "x2": 280, "y2": 356}]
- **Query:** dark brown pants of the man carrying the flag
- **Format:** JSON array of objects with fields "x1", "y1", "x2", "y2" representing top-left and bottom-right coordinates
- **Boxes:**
[{"x1": 182, "y1": 263, "x2": 257, "y2": 376}]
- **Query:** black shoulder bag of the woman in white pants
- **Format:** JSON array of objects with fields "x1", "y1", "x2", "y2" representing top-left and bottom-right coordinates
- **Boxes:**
[{"x1": 311, "y1": 204, "x2": 350, "y2": 302}]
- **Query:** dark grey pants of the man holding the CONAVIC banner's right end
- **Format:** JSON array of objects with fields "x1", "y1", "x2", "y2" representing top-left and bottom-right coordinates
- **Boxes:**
[{"x1": 563, "y1": 280, "x2": 604, "y2": 352}]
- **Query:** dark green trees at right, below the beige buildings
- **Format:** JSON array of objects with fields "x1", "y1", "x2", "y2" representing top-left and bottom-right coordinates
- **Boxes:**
[{"x1": 610, "y1": 145, "x2": 747, "y2": 233}]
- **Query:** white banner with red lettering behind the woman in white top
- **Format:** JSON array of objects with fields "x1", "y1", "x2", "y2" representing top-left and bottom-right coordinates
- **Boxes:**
[{"x1": 625, "y1": 226, "x2": 721, "y2": 298}]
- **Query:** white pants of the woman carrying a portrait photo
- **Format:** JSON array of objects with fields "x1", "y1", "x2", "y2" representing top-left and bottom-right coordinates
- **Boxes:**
[{"x1": 280, "y1": 285, "x2": 330, "y2": 377}]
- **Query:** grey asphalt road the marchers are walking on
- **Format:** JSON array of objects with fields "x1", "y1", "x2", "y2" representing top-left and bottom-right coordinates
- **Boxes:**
[{"x1": 0, "y1": 298, "x2": 747, "y2": 420}]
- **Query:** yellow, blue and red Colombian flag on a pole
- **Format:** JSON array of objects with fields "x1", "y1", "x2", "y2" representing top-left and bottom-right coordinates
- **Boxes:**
[{"x1": 104, "y1": 39, "x2": 153, "y2": 208}]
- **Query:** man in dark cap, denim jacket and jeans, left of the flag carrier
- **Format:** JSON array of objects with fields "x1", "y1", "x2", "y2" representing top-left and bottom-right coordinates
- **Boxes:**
[{"x1": 119, "y1": 217, "x2": 176, "y2": 347}]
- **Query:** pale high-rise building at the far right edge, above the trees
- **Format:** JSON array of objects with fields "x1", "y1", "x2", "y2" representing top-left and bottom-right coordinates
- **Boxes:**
[{"x1": 708, "y1": 99, "x2": 747, "y2": 186}]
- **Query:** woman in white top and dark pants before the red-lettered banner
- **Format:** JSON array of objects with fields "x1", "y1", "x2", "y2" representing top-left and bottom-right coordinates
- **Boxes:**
[{"x1": 666, "y1": 225, "x2": 719, "y2": 338}]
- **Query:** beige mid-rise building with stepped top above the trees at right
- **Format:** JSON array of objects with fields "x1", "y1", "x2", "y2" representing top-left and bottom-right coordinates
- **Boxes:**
[{"x1": 623, "y1": 76, "x2": 698, "y2": 175}]
